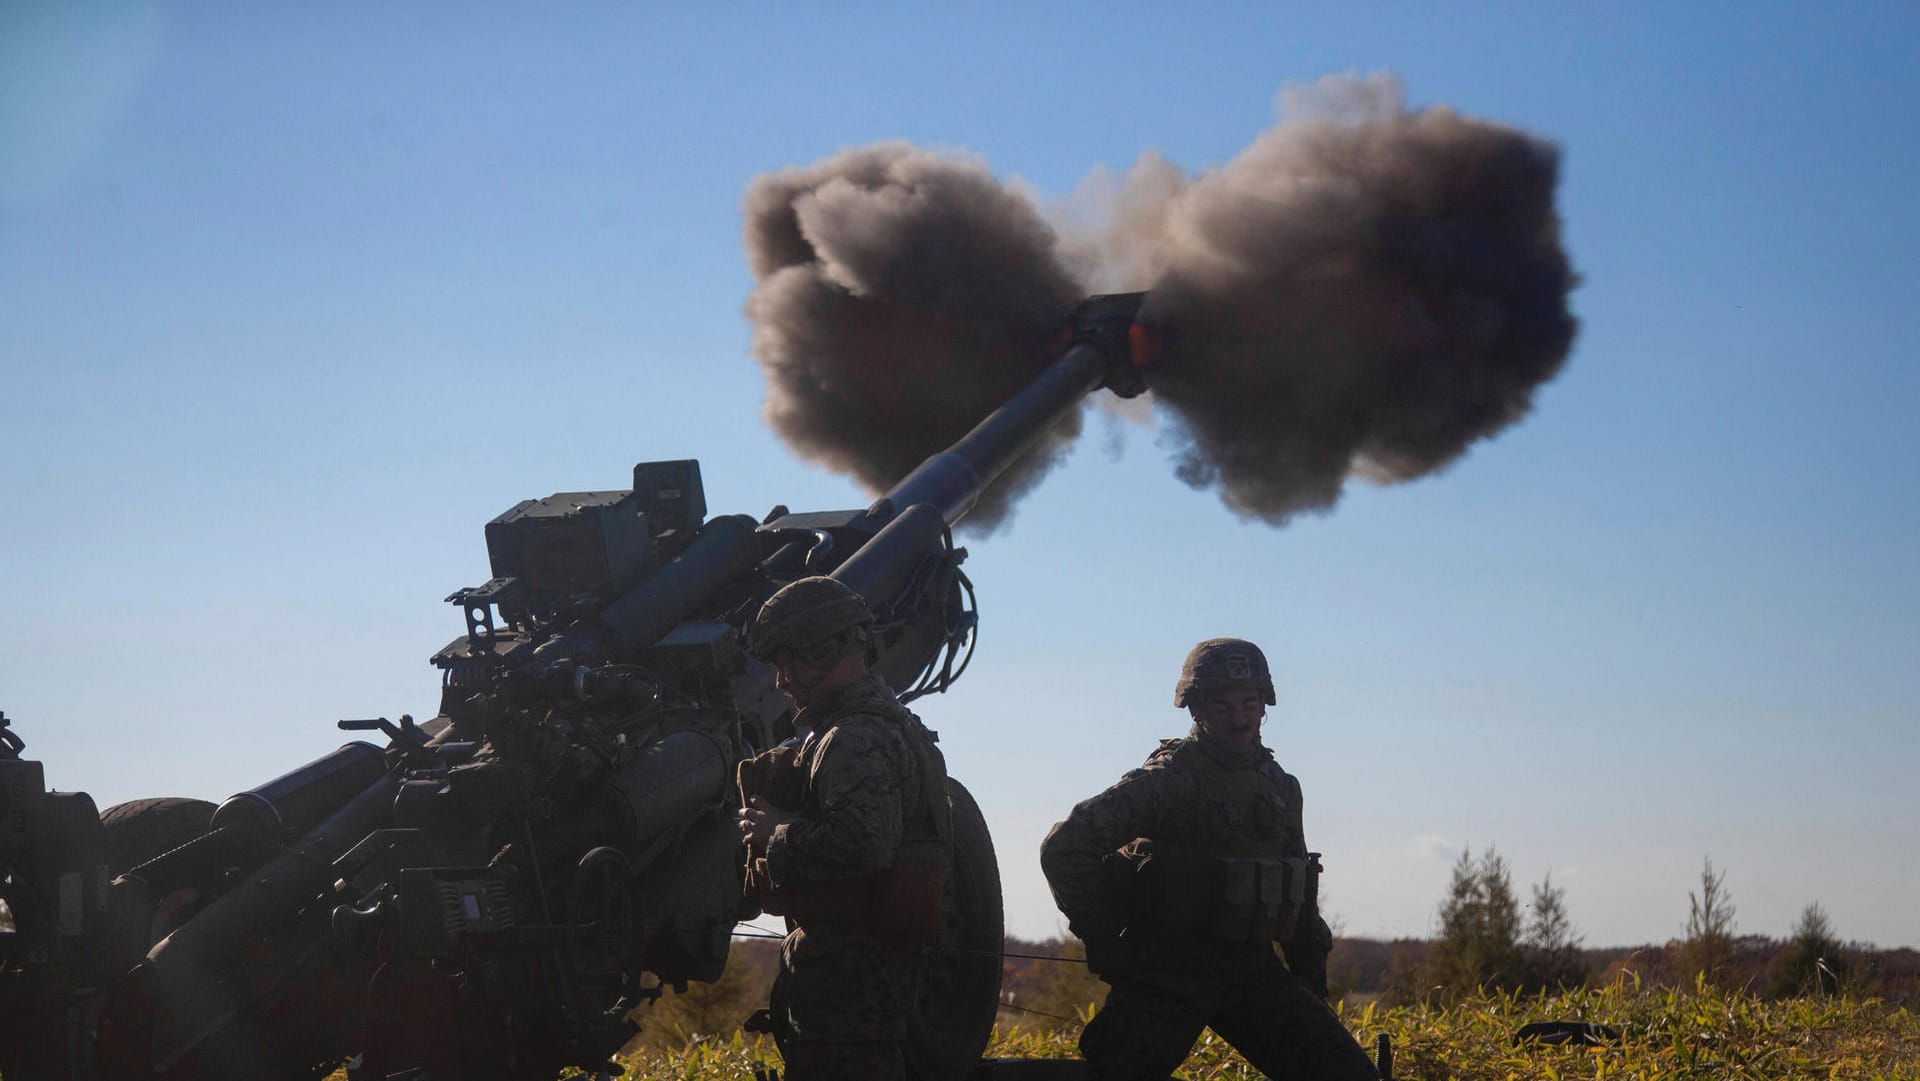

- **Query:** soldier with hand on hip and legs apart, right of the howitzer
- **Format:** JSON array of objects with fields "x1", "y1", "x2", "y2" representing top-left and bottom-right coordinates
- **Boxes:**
[{"x1": 1041, "y1": 637, "x2": 1379, "y2": 1081}]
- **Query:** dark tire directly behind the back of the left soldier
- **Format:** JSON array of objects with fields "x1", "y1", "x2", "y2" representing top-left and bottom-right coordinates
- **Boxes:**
[{"x1": 902, "y1": 778, "x2": 1006, "y2": 1081}]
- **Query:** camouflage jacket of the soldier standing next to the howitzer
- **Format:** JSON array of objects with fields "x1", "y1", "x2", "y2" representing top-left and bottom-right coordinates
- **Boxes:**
[{"x1": 766, "y1": 674, "x2": 945, "y2": 887}]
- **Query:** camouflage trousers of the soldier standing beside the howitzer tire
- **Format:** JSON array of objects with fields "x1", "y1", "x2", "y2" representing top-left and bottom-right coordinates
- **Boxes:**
[{"x1": 772, "y1": 922, "x2": 910, "y2": 1081}]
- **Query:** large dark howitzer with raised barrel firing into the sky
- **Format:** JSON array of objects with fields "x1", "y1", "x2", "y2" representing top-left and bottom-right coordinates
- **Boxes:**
[{"x1": 0, "y1": 294, "x2": 1142, "y2": 1081}]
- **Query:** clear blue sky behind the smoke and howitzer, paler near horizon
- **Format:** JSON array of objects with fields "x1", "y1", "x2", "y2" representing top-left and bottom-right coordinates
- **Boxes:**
[{"x1": 0, "y1": 0, "x2": 1920, "y2": 947}]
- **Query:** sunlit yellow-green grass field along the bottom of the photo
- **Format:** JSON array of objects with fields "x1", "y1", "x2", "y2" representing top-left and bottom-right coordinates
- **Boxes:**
[{"x1": 626, "y1": 981, "x2": 1920, "y2": 1081}]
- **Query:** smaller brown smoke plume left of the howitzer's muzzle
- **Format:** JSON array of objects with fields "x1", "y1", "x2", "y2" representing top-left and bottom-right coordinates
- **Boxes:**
[{"x1": 745, "y1": 142, "x2": 1083, "y2": 530}]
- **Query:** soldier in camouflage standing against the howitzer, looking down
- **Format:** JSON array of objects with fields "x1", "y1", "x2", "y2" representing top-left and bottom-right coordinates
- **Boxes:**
[{"x1": 739, "y1": 578, "x2": 950, "y2": 1081}]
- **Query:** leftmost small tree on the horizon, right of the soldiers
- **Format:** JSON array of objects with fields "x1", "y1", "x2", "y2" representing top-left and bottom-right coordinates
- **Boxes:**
[{"x1": 1427, "y1": 847, "x2": 1521, "y2": 997}]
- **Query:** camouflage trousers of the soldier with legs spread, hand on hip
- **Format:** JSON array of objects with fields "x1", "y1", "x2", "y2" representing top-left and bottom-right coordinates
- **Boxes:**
[{"x1": 1081, "y1": 960, "x2": 1379, "y2": 1081}]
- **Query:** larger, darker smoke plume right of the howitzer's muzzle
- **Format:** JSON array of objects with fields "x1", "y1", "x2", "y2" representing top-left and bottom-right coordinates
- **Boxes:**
[{"x1": 1110, "y1": 77, "x2": 1574, "y2": 522}]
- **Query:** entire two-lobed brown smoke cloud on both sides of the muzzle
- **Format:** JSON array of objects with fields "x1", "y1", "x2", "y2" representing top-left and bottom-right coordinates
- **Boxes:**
[{"x1": 747, "y1": 77, "x2": 1576, "y2": 528}]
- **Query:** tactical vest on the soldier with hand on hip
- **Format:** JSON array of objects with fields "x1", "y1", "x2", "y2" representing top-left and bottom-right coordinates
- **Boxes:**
[{"x1": 1106, "y1": 739, "x2": 1319, "y2": 943}]
